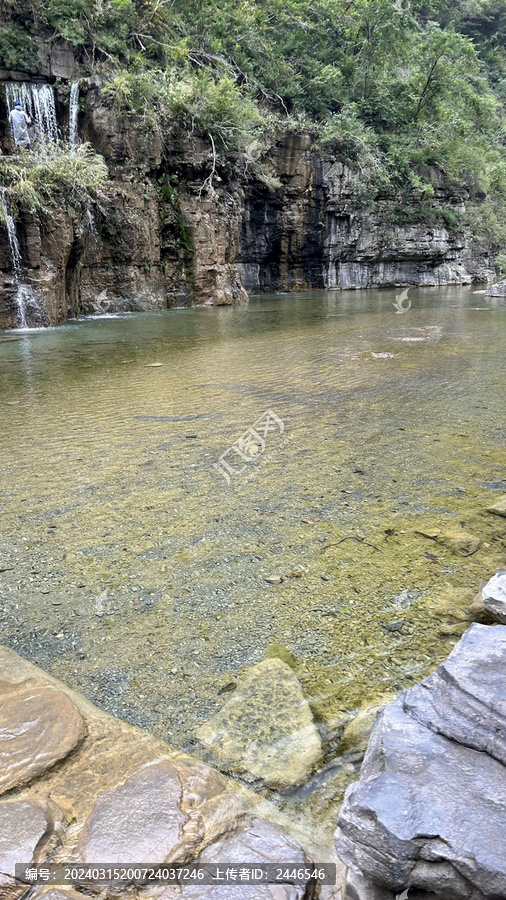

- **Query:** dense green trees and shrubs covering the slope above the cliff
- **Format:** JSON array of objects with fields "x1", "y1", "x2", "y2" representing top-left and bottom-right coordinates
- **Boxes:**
[{"x1": 0, "y1": 0, "x2": 506, "y2": 256}]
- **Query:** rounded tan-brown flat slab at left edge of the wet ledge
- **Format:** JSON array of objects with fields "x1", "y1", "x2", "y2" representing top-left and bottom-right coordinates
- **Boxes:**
[{"x1": 0, "y1": 679, "x2": 84, "y2": 794}]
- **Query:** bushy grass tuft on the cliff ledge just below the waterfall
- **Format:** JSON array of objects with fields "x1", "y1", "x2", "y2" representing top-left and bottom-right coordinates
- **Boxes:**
[{"x1": 0, "y1": 144, "x2": 108, "y2": 221}]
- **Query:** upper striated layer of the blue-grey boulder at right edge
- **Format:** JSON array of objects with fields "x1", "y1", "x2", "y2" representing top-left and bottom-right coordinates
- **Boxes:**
[{"x1": 402, "y1": 624, "x2": 506, "y2": 765}]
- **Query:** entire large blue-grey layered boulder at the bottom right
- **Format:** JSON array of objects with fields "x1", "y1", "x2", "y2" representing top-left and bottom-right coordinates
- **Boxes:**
[{"x1": 335, "y1": 624, "x2": 506, "y2": 900}]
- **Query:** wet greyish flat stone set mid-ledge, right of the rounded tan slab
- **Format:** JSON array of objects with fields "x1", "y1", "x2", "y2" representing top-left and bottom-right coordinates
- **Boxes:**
[{"x1": 78, "y1": 760, "x2": 187, "y2": 864}]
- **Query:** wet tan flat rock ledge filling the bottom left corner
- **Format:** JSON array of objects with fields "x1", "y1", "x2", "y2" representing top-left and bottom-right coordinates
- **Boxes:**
[{"x1": 0, "y1": 646, "x2": 344, "y2": 900}]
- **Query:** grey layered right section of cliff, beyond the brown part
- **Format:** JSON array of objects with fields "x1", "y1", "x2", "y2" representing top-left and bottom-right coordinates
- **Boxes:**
[{"x1": 237, "y1": 135, "x2": 493, "y2": 291}]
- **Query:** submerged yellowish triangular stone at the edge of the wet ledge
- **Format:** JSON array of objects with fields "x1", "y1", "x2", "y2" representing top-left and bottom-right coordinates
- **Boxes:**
[{"x1": 196, "y1": 659, "x2": 322, "y2": 790}]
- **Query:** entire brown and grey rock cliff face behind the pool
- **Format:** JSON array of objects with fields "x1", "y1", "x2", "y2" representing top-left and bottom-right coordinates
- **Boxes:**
[{"x1": 0, "y1": 73, "x2": 493, "y2": 328}]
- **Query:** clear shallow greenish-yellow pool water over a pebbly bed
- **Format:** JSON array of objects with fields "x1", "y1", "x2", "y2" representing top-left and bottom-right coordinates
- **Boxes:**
[{"x1": 0, "y1": 288, "x2": 506, "y2": 844}]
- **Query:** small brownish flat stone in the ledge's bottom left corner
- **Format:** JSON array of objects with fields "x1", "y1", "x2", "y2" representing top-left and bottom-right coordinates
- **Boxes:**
[{"x1": 0, "y1": 800, "x2": 59, "y2": 900}]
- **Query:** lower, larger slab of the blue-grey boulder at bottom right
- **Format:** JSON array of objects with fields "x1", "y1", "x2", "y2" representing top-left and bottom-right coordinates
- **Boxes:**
[{"x1": 335, "y1": 699, "x2": 506, "y2": 900}]
